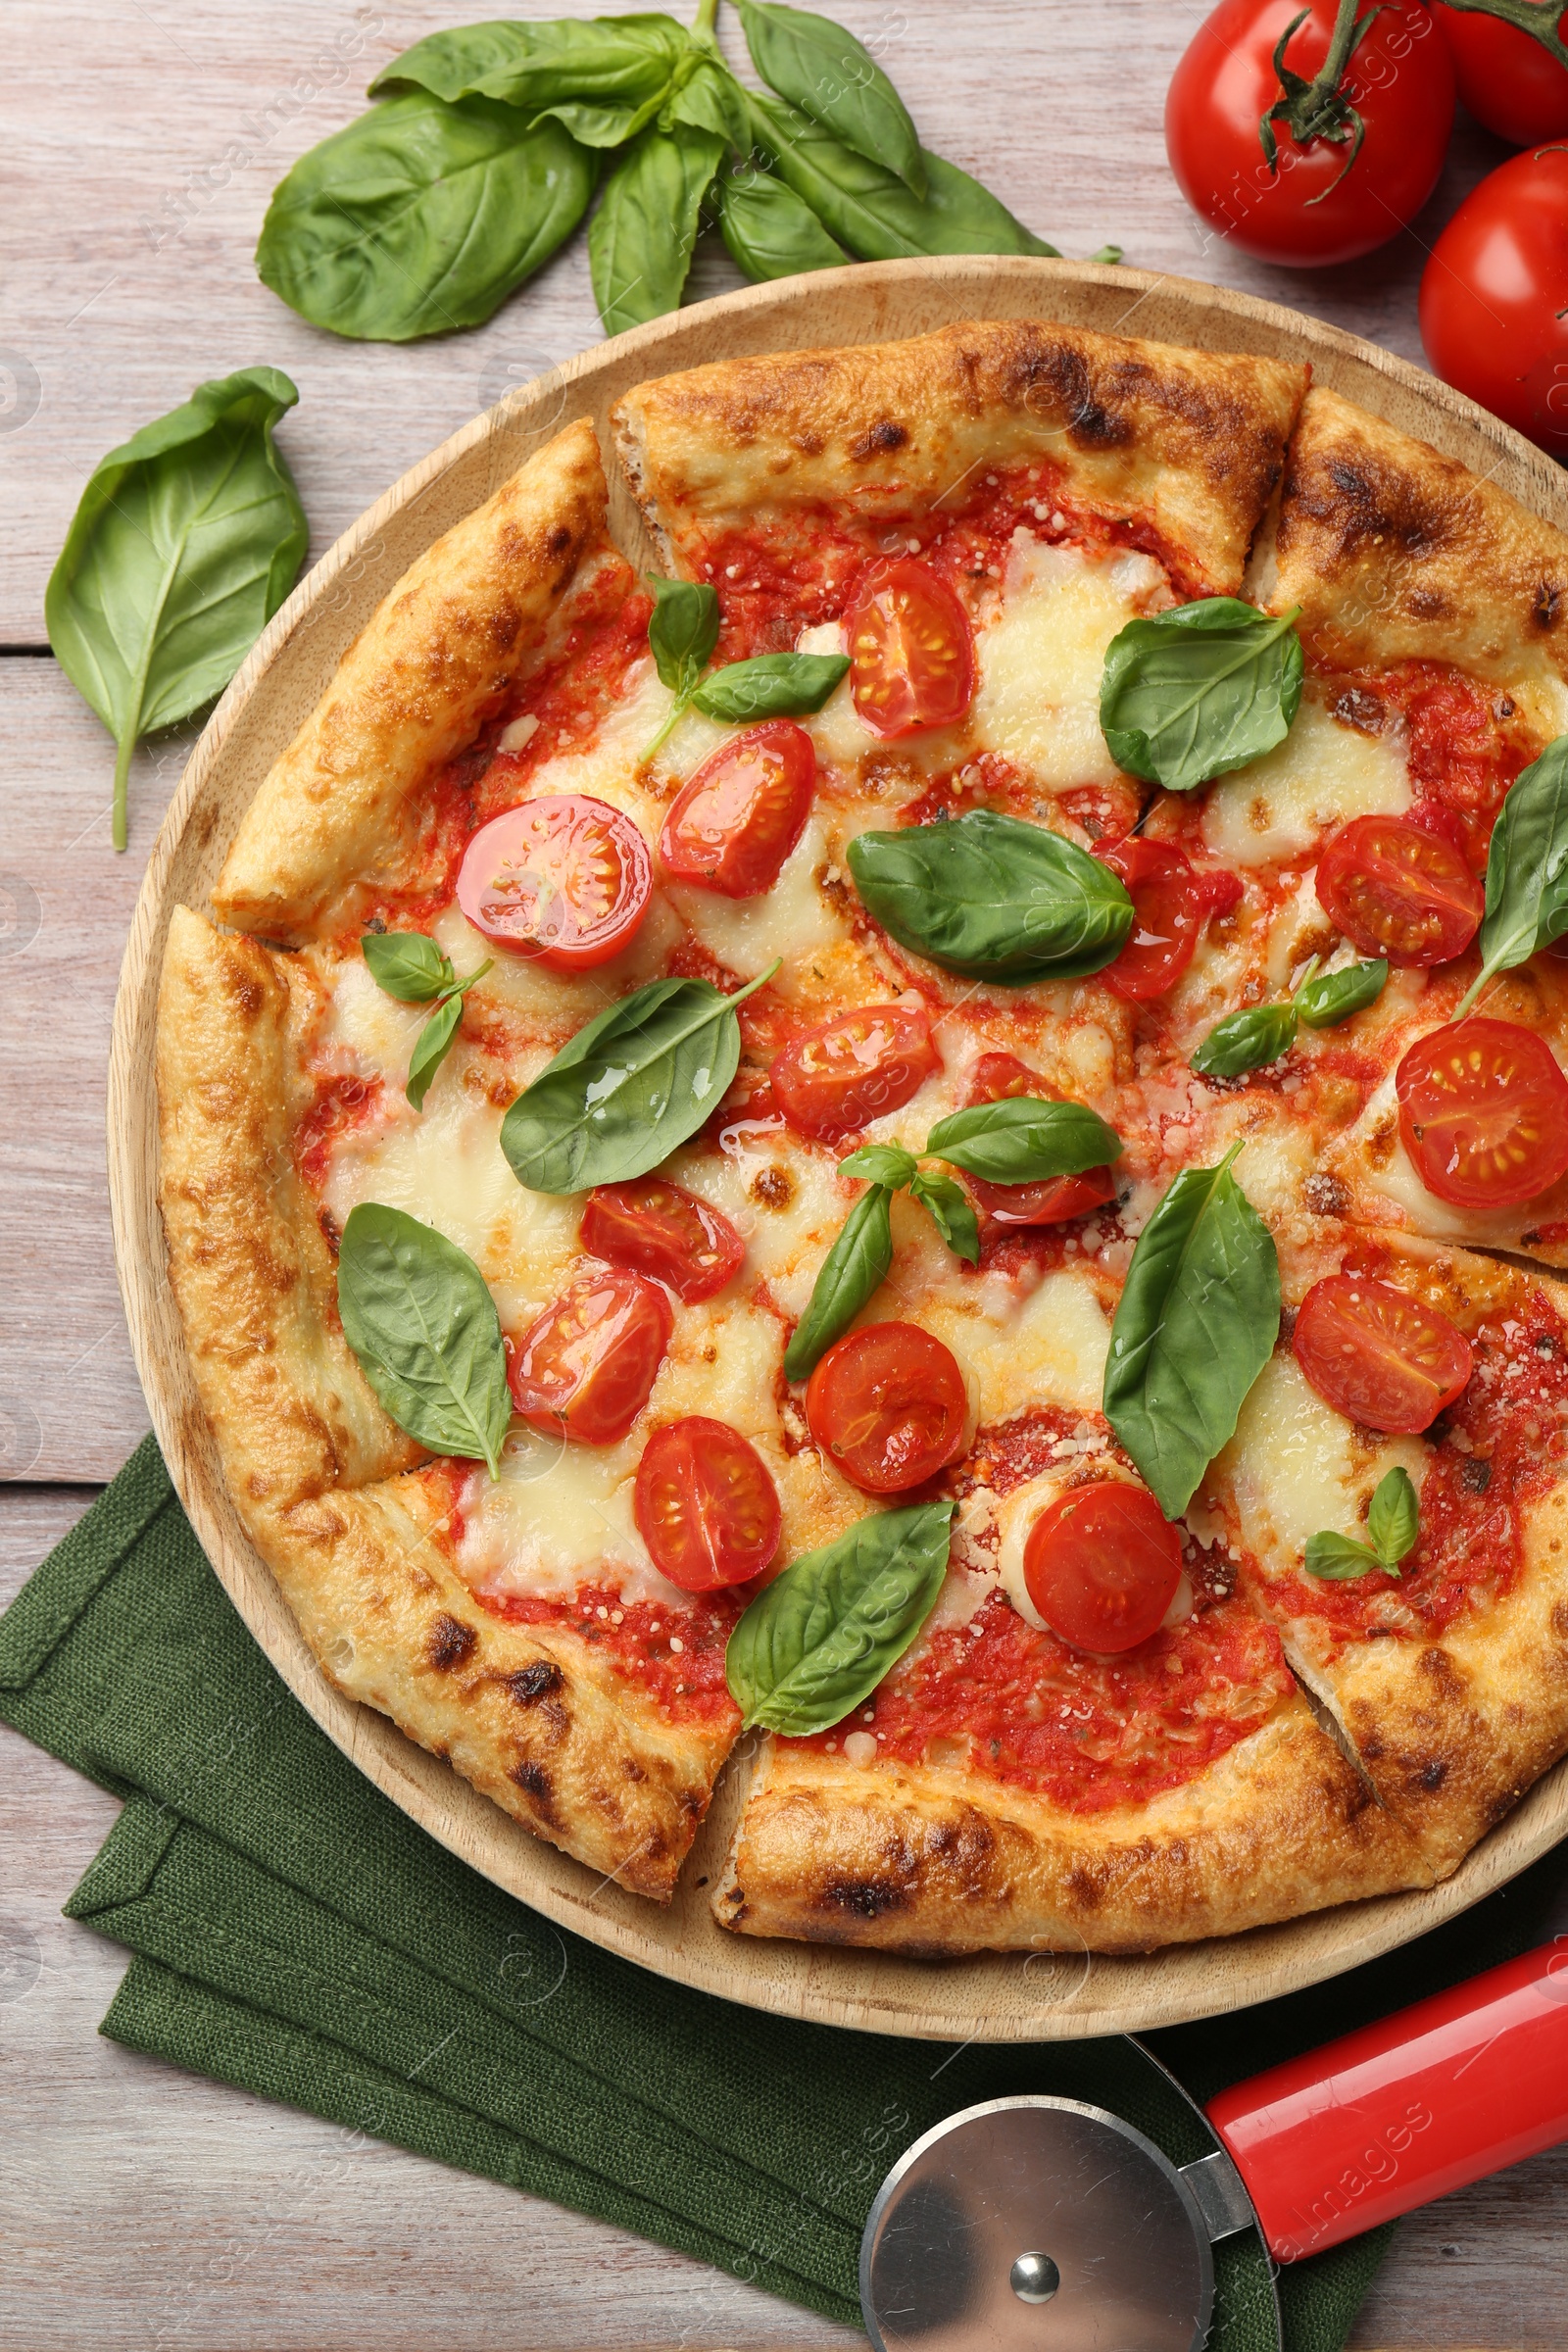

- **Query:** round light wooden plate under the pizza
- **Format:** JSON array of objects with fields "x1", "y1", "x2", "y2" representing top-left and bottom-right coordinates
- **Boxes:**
[{"x1": 108, "y1": 259, "x2": 1568, "y2": 2041}]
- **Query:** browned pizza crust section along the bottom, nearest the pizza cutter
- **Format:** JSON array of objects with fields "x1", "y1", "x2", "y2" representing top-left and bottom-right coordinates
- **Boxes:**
[{"x1": 712, "y1": 1693, "x2": 1432, "y2": 1957}]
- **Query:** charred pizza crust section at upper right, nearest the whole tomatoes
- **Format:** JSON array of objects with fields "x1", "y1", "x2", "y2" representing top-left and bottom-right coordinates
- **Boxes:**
[{"x1": 1262, "y1": 388, "x2": 1568, "y2": 684}]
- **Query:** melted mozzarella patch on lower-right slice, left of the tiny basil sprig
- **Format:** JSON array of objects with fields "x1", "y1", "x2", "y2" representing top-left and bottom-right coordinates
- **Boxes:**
[{"x1": 1220, "y1": 1350, "x2": 1427, "y2": 1571}]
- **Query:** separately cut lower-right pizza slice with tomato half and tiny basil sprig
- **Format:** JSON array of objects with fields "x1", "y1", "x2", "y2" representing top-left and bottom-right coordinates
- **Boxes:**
[{"x1": 1190, "y1": 1230, "x2": 1568, "y2": 1875}]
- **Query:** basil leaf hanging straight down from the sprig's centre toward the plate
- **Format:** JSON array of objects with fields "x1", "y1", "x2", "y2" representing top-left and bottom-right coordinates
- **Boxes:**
[{"x1": 588, "y1": 124, "x2": 724, "y2": 334}]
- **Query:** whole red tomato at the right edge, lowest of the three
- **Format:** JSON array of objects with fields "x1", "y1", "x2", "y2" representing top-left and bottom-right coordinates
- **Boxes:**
[{"x1": 1420, "y1": 146, "x2": 1568, "y2": 459}]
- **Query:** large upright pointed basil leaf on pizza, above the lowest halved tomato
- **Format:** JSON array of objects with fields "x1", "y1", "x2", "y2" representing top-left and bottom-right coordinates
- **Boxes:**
[{"x1": 1104, "y1": 1146, "x2": 1279, "y2": 1519}]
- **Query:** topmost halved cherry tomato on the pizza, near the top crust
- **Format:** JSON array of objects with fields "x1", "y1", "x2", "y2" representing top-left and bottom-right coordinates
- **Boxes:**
[{"x1": 844, "y1": 555, "x2": 976, "y2": 736}]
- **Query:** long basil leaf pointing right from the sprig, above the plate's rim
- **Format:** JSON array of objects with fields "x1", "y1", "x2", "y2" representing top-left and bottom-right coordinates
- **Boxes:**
[{"x1": 745, "y1": 89, "x2": 1060, "y2": 261}]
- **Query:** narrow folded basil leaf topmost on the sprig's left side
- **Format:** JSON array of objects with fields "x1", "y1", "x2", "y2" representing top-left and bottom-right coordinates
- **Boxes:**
[{"x1": 369, "y1": 17, "x2": 689, "y2": 108}]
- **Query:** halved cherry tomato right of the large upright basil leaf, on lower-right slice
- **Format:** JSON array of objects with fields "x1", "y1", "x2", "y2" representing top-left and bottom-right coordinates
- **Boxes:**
[{"x1": 1291, "y1": 1275, "x2": 1469, "y2": 1437}]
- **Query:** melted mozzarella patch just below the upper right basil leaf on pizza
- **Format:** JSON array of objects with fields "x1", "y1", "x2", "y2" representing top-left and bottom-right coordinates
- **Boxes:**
[{"x1": 1203, "y1": 696, "x2": 1410, "y2": 865}]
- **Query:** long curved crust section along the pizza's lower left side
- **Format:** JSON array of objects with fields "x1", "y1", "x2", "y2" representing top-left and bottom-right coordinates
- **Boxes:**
[{"x1": 158, "y1": 907, "x2": 733, "y2": 1900}]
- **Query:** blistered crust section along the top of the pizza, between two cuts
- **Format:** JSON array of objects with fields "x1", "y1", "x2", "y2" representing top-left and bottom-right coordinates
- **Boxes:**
[{"x1": 612, "y1": 319, "x2": 1307, "y2": 595}]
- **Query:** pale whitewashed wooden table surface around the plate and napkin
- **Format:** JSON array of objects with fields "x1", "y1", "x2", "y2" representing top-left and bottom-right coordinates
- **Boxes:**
[{"x1": 0, "y1": 0, "x2": 1568, "y2": 2352}]
